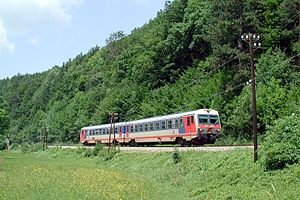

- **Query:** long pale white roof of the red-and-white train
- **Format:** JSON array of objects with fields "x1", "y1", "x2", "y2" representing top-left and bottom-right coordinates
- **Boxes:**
[{"x1": 82, "y1": 109, "x2": 219, "y2": 130}]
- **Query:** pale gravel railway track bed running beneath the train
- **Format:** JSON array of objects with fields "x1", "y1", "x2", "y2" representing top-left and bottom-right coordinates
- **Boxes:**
[{"x1": 49, "y1": 146, "x2": 253, "y2": 152}]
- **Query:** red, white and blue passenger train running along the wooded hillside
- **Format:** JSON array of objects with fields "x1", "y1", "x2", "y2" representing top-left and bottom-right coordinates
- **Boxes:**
[{"x1": 80, "y1": 109, "x2": 221, "y2": 146}]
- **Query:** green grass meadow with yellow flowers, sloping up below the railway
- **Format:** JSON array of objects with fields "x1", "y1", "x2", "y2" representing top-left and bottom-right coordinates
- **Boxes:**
[{"x1": 0, "y1": 149, "x2": 300, "y2": 200}]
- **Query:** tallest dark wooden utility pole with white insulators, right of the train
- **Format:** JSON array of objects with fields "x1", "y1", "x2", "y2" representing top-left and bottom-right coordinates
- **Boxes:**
[{"x1": 242, "y1": 33, "x2": 261, "y2": 162}]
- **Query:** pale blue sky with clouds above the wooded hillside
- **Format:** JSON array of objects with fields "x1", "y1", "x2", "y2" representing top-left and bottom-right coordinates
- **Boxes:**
[{"x1": 0, "y1": 0, "x2": 165, "y2": 79}]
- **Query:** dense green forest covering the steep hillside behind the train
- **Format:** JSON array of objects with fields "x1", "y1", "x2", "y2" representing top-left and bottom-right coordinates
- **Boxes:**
[{"x1": 0, "y1": 0, "x2": 300, "y2": 147}]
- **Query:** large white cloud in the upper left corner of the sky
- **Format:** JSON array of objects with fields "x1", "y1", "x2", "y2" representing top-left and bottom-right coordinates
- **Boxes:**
[{"x1": 0, "y1": 0, "x2": 83, "y2": 52}]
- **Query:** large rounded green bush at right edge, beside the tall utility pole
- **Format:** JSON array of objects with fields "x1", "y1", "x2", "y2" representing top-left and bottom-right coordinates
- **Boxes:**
[{"x1": 259, "y1": 114, "x2": 300, "y2": 171}]
